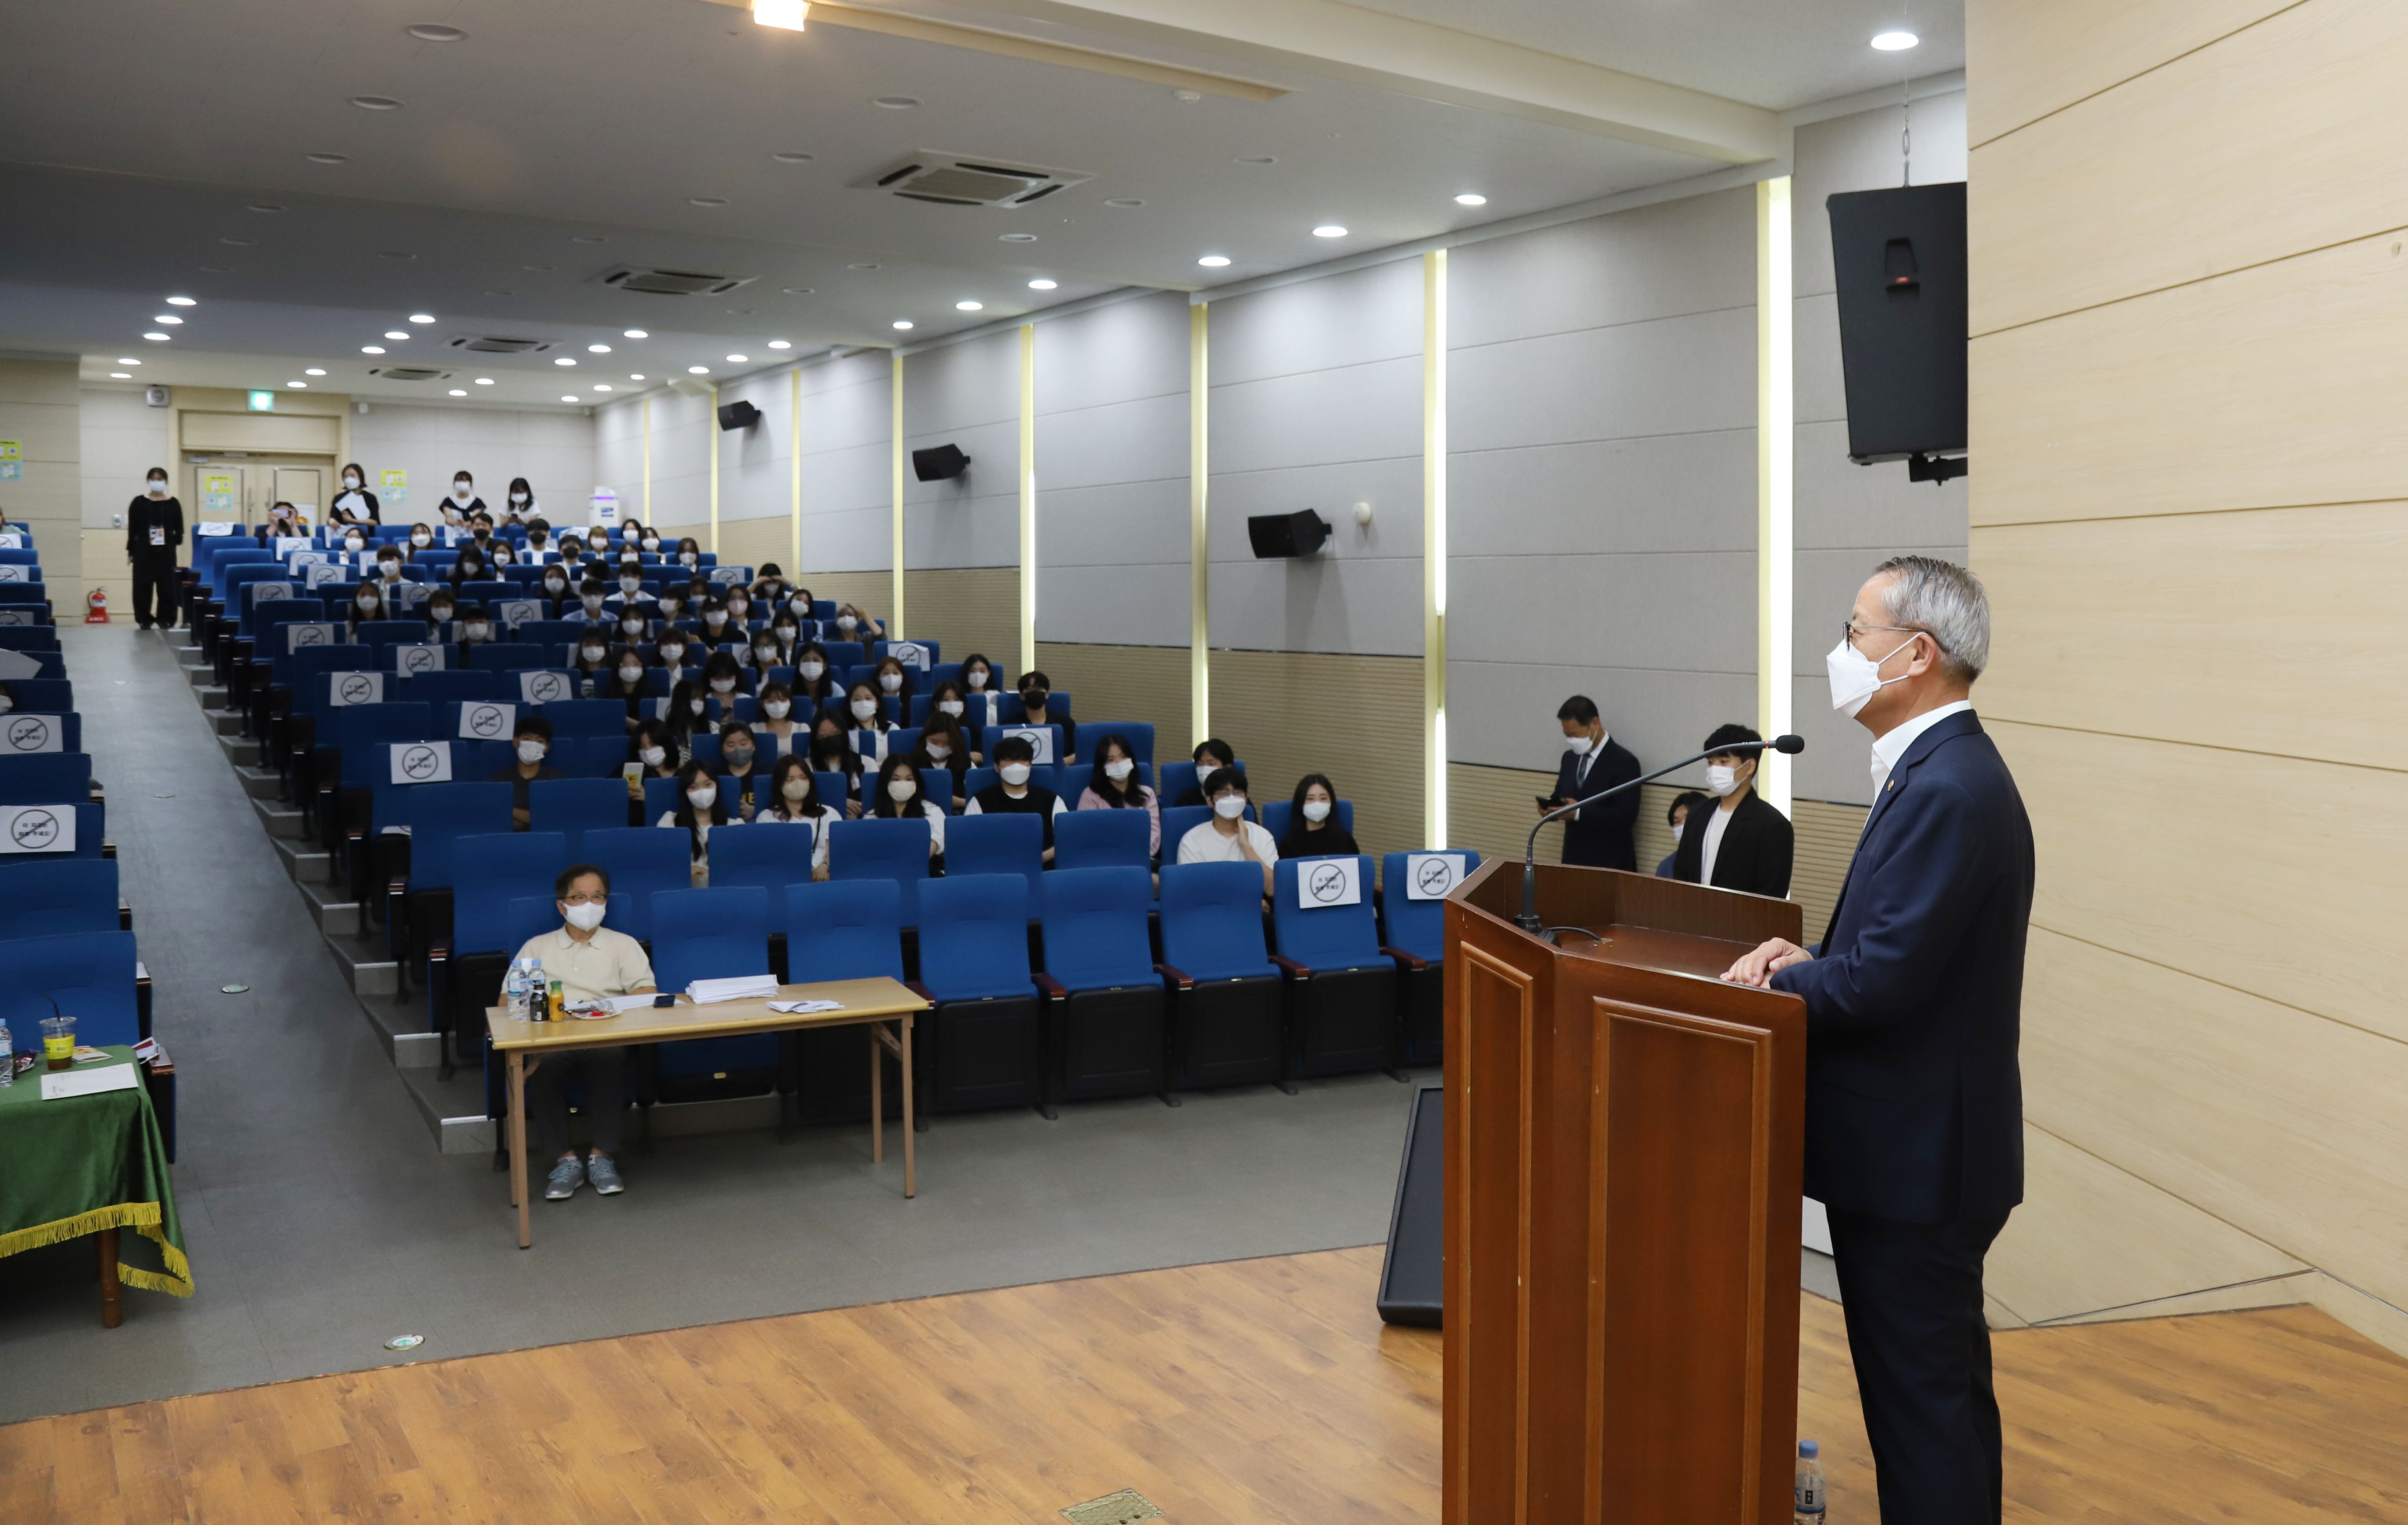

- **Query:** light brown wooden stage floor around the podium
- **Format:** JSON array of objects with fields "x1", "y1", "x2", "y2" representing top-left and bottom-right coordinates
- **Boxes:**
[{"x1": 0, "y1": 1250, "x2": 2408, "y2": 1525}]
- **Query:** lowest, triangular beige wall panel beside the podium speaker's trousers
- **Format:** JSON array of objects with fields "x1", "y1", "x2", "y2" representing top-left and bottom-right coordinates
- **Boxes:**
[{"x1": 1984, "y1": 1125, "x2": 2309, "y2": 1323}]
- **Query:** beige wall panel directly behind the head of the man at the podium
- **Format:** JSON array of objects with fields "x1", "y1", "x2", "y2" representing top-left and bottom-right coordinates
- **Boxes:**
[{"x1": 1972, "y1": 503, "x2": 2408, "y2": 766}]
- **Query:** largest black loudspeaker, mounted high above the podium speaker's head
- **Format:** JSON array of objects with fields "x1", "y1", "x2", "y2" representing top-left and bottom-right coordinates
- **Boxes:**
[{"x1": 1825, "y1": 181, "x2": 1968, "y2": 482}]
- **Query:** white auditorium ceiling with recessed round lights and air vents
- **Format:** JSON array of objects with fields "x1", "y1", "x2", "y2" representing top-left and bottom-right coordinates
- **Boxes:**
[{"x1": 0, "y1": 0, "x2": 1960, "y2": 405}]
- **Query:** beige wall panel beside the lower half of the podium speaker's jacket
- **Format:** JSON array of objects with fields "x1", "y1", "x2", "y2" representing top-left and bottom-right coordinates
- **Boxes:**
[{"x1": 2023, "y1": 927, "x2": 2408, "y2": 1303}]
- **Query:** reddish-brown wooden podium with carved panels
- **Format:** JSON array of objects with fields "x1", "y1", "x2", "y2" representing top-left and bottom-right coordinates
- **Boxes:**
[{"x1": 1443, "y1": 858, "x2": 1806, "y2": 1525}]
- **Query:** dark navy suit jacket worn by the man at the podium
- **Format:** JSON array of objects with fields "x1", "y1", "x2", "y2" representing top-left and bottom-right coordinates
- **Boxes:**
[{"x1": 1772, "y1": 713, "x2": 2032, "y2": 1224}]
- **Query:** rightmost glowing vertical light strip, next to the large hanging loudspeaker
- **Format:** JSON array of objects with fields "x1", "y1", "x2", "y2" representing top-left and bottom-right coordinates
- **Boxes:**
[{"x1": 1755, "y1": 176, "x2": 1796, "y2": 814}]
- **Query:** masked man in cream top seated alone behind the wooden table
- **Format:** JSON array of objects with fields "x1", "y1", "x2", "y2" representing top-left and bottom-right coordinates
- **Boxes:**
[{"x1": 518, "y1": 863, "x2": 653, "y2": 1202}]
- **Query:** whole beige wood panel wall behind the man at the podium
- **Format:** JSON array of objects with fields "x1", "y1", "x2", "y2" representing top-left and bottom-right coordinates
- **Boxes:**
[{"x1": 1968, "y1": 0, "x2": 2408, "y2": 1349}]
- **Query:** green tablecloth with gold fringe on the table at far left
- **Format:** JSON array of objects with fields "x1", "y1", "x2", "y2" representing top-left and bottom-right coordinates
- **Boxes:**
[{"x1": 0, "y1": 1046, "x2": 193, "y2": 1296}]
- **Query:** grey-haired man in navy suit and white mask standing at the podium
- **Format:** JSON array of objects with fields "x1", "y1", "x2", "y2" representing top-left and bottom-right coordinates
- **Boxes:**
[{"x1": 1722, "y1": 556, "x2": 2032, "y2": 1525}]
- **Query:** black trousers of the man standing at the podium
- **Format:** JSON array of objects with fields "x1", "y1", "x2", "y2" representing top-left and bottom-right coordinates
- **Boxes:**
[{"x1": 1830, "y1": 1207, "x2": 2006, "y2": 1525}]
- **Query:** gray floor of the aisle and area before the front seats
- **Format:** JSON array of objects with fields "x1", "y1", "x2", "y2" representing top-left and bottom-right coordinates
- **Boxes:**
[{"x1": 0, "y1": 624, "x2": 1435, "y2": 1422}]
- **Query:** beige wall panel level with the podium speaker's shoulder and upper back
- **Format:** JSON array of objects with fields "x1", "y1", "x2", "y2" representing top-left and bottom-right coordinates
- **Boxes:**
[{"x1": 1991, "y1": 720, "x2": 2408, "y2": 1040}]
